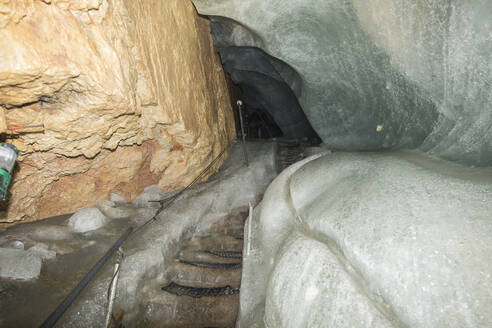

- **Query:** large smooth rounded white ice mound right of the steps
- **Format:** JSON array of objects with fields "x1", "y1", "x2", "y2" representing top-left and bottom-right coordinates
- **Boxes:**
[{"x1": 239, "y1": 152, "x2": 492, "y2": 328}]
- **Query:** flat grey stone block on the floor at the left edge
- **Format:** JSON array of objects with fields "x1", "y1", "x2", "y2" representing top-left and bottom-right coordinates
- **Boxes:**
[{"x1": 0, "y1": 248, "x2": 42, "y2": 280}]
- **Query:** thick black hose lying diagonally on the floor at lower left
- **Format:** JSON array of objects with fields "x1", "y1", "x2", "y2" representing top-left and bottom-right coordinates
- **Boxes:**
[{"x1": 41, "y1": 227, "x2": 133, "y2": 328}]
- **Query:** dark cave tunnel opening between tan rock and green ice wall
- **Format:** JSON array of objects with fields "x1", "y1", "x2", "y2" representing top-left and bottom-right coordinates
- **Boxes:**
[{"x1": 210, "y1": 17, "x2": 319, "y2": 142}]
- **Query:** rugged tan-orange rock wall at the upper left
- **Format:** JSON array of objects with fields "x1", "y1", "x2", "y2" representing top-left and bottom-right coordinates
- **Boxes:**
[{"x1": 0, "y1": 0, "x2": 235, "y2": 222}]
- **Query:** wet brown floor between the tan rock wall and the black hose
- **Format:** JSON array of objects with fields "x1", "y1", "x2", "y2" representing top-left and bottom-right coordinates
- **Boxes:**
[{"x1": 0, "y1": 211, "x2": 145, "y2": 328}]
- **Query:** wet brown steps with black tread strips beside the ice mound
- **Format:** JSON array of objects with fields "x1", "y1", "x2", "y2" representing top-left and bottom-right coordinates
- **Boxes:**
[{"x1": 139, "y1": 207, "x2": 248, "y2": 328}]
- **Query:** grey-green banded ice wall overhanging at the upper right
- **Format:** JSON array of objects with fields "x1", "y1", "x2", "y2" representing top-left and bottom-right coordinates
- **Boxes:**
[{"x1": 193, "y1": 0, "x2": 492, "y2": 166}]
